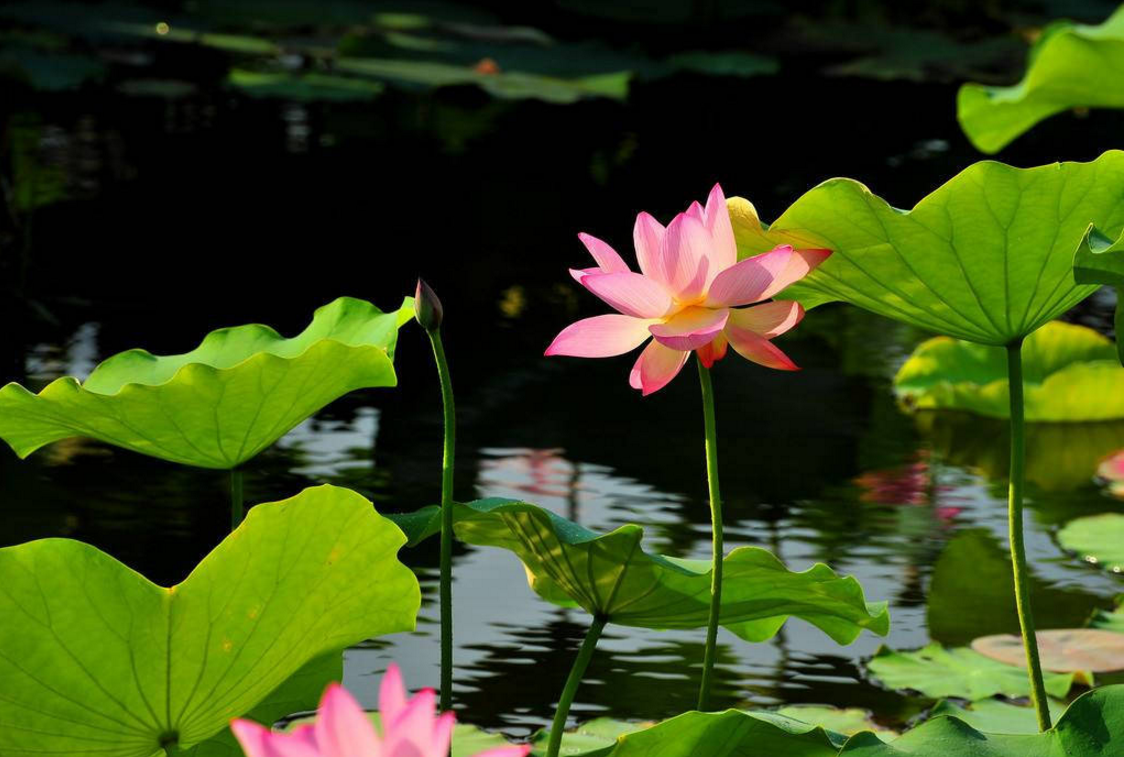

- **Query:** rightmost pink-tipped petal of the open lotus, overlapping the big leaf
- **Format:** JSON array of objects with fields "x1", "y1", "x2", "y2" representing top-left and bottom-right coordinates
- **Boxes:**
[{"x1": 706, "y1": 244, "x2": 832, "y2": 307}]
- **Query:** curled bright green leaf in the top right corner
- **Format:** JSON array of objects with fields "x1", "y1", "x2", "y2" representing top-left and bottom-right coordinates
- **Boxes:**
[{"x1": 957, "y1": 9, "x2": 1124, "y2": 153}]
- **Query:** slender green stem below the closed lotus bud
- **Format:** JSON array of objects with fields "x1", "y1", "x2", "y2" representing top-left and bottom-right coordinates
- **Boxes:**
[{"x1": 426, "y1": 328, "x2": 456, "y2": 712}]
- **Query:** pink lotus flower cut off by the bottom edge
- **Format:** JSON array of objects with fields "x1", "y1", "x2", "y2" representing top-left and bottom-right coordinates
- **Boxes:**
[{"x1": 230, "y1": 665, "x2": 531, "y2": 757}]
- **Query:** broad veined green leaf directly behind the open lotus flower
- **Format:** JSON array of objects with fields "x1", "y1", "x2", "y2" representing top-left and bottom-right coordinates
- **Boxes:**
[{"x1": 729, "y1": 151, "x2": 1124, "y2": 345}]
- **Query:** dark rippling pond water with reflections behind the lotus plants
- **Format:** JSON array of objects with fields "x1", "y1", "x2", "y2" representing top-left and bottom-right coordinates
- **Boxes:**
[{"x1": 0, "y1": 48, "x2": 1124, "y2": 735}]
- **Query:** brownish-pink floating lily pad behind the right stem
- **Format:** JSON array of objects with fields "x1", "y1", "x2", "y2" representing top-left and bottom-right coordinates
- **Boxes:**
[{"x1": 972, "y1": 629, "x2": 1124, "y2": 673}]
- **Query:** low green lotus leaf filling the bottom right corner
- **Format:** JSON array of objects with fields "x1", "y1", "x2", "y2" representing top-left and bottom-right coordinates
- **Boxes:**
[{"x1": 840, "y1": 686, "x2": 1124, "y2": 757}]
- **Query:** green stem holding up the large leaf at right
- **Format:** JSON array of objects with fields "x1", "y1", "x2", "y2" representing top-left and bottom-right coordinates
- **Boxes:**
[{"x1": 1007, "y1": 340, "x2": 1050, "y2": 731}]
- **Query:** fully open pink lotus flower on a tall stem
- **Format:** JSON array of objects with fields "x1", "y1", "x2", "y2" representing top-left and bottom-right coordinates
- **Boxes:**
[{"x1": 546, "y1": 184, "x2": 831, "y2": 396}]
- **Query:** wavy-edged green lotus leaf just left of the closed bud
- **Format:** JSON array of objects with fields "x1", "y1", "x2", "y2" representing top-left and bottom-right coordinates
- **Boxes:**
[{"x1": 0, "y1": 297, "x2": 413, "y2": 469}]
